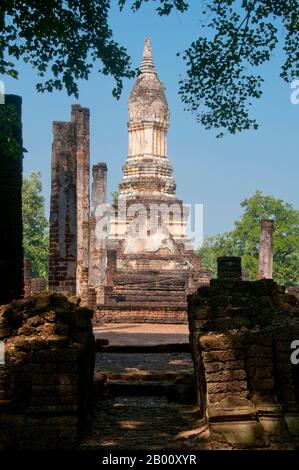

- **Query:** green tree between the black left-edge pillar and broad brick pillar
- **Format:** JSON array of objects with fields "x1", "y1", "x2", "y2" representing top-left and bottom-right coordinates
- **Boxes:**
[{"x1": 22, "y1": 172, "x2": 49, "y2": 279}]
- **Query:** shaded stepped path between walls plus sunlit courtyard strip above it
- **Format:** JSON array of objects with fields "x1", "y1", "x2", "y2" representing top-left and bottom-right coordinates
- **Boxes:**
[{"x1": 79, "y1": 323, "x2": 291, "y2": 451}]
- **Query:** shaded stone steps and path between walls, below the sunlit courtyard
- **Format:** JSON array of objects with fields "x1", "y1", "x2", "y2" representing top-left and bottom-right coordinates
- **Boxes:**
[{"x1": 80, "y1": 345, "x2": 210, "y2": 450}]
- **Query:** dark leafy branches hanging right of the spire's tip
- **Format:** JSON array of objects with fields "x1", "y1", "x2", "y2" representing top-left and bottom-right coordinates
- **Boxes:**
[{"x1": 120, "y1": 0, "x2": 299, "y2": 137}]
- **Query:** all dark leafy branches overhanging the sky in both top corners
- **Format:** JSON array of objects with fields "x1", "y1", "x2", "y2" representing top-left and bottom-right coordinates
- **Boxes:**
[{"x1": 0, "y1": 0, "x2": 299, "y2": 141}]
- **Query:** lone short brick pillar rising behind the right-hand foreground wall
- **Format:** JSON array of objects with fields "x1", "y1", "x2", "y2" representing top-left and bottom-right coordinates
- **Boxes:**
[{"x1": 258, "y1": 219, "x2": 274, "y2": 279}]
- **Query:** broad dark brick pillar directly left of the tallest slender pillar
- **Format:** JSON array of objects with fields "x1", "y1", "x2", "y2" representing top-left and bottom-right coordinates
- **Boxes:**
[{"x1": 49, "y1": 121, "x2": 77, "y2": 295}]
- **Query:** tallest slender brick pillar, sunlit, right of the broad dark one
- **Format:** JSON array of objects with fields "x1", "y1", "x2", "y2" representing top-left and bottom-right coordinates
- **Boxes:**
[{"x1": 72, "y1": 105, "x2": 90, "y2": 305}]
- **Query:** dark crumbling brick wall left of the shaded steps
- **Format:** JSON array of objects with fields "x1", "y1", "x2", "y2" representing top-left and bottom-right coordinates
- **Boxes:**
[{"x1": 0, "y1": 293, "x2": 94, "y2": 449}]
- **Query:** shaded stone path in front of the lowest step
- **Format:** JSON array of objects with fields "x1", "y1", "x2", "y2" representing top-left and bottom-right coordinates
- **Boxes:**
[{"x1": 81, "y1": 396, "x2": 209, "y2": 450}]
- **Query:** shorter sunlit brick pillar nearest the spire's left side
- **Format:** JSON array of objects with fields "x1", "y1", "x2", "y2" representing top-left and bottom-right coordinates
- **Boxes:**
[{"x1": 89, "y1": 163, "x2": 107, "y2": 304}]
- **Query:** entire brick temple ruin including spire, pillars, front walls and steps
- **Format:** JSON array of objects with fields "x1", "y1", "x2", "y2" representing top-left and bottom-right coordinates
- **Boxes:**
[{"x1": 0, "y1": 40, "x2": 299, "y2": 452}]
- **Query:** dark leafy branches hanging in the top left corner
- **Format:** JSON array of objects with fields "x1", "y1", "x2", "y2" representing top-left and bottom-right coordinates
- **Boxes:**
[{"x1": 0, "y1": 0, "x2": 134, "y2": 97}]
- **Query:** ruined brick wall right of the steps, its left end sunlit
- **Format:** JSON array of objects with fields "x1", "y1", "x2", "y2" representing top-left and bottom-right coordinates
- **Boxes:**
[{"x1": 188, "y1": 279, "x2": 299, "y2": 448}]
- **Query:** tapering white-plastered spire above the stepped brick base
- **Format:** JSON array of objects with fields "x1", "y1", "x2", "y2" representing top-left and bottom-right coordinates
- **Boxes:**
[{"x1": 119, "y1": 38, "x2": 176, "y2": 201}]
